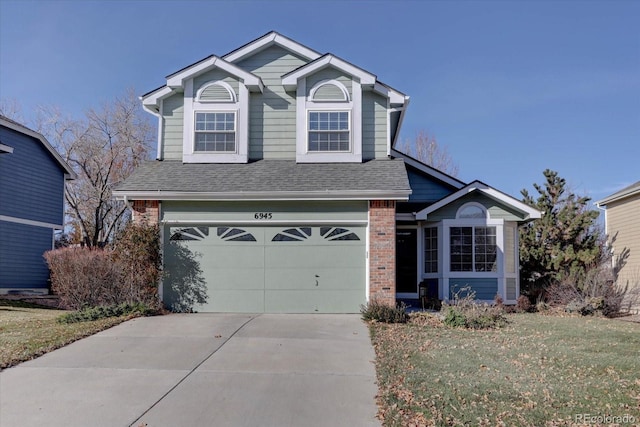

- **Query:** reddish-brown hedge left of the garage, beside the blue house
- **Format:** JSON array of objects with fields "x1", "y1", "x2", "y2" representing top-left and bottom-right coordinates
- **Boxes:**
[{"x1": 44, "y1": 224, "x2": 161, "y2": 310}]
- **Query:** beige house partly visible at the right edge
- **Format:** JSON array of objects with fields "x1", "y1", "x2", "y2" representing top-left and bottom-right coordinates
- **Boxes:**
[{"x1": 596, "y1": 181, "x2": 640, "y2": 308}]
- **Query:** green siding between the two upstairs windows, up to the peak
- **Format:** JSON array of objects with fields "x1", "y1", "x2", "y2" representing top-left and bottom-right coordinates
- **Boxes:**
[{"x1": 236, "y1": 46, "x2": 307, "y2": 159}]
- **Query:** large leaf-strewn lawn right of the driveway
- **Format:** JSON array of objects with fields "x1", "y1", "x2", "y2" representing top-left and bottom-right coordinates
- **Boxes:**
[{"x1": 371, "y1": 314, "x2": 640, "y2": 426}]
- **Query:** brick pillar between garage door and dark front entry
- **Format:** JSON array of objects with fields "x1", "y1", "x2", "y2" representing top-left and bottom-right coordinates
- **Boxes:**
[{"x1": 369, "y1": 200, "x2": 396, "y2": 305}]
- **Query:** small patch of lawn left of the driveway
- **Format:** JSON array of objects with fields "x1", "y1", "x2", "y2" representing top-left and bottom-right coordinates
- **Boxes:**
[{"x1": 0, "y1": 299, "x2": 127, "y2": 369}]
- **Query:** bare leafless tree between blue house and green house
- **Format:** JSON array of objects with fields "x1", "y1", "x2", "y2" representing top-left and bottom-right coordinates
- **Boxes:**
[{"x1": 38, "y1": 90, "x2": 152, "y2": 246}]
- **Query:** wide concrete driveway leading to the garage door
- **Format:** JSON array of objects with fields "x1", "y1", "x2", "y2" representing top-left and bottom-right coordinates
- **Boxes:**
[{"x1": 0, "y1": 314, "x2": 380, "y2": 427}]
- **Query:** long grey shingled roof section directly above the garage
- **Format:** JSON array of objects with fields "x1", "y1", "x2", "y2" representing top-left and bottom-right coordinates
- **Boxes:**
[{"x1": 113, "y1": 159, "x2": 411, "y2": 200}]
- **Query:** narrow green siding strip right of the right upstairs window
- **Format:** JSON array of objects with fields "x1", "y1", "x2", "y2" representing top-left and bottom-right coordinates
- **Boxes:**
[{"x1": 362, "y1": 91, "x2": 387, "y2": 160}]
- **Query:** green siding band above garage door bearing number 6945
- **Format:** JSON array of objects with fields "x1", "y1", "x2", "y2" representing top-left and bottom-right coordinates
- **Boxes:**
[{"x1": 162, "y1": 201, "x2": 368, "y2": 225}]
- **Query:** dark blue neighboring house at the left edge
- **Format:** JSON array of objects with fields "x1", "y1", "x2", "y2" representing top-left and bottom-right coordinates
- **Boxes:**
[{"x1": 0, "y1": 116, "x2": 75, "y2": 293}]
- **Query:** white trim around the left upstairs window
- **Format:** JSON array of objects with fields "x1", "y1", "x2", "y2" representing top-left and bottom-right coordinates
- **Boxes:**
[{"x1": 182, "y1": 79, "x2": 249, "y2": 163}]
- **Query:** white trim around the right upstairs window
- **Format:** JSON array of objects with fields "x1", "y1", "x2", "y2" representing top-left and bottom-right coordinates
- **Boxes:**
[{"x1": 296, "y1": 78, "x2": 362, "y2": 163}]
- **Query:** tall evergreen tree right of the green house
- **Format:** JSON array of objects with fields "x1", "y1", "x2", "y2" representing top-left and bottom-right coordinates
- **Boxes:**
[{"x1": 520, "y1": 169, "x2": 604, "y2": 297}]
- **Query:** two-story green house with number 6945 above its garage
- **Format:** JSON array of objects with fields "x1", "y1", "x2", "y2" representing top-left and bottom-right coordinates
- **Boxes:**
[{"x1": 114, "y1": 32, "x2": 540, "y2": 313}]
